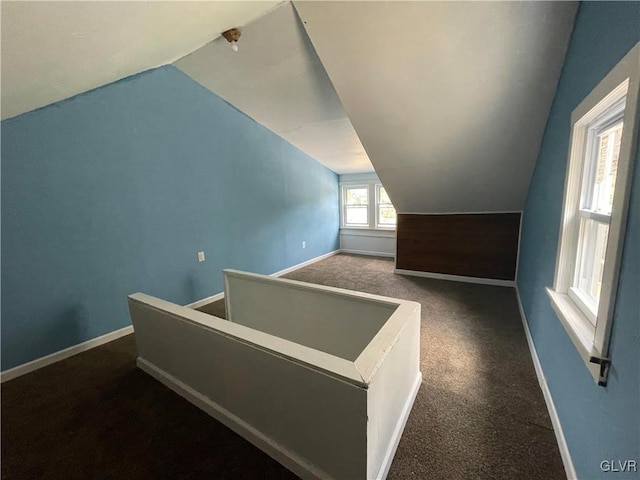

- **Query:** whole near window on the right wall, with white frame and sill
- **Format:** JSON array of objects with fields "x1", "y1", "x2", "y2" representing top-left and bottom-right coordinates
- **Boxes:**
[{"x1": 547, "y1": 44, "x2": 640, "y2": 385}]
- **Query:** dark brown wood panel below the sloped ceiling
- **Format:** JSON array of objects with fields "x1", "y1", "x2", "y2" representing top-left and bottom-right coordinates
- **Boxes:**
[{"x1": 396, "y1": 213, "x2": 520, "y2": 280}]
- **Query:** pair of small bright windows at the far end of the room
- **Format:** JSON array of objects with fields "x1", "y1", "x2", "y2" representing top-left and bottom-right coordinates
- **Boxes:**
[{"x1": 340, "y1": 180, "x2": 396, "y2": 232}]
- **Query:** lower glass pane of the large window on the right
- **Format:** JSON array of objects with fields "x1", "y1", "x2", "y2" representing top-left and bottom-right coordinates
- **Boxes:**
[{"x1": 573, "y1": 218, "x2": 609, "y2": 305}]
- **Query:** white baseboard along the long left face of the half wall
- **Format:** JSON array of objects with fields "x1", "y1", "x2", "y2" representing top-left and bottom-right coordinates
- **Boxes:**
[{"x1": 136, "y1": 357, "x2": 329, "y2": 480}]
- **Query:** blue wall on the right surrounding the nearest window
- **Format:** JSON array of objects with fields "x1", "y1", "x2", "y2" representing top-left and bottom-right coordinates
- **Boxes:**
[{"x1": 518, "y1": 2, "x2": 640, "y2": 479}]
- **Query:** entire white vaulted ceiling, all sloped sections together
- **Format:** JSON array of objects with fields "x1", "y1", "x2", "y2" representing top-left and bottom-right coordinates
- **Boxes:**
[{"x1": 1, "y1": 1, "x2": 577, "y2": 213}]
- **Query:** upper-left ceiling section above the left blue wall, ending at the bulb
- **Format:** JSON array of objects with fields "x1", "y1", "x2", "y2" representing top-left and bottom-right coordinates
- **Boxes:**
[{"x1": 1, "y1": 1, "x2": 280, "y2": 119}]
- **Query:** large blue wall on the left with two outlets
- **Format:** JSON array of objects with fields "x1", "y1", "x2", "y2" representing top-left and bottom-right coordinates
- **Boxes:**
[{"x1": 2, "y1": 66, "x2": 339, "y2": 370}]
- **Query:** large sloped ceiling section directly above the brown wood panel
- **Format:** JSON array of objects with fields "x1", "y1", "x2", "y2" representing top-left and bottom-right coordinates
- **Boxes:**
[{"x1": 294, "y1": 1, "x2": 577, "y2": 213}]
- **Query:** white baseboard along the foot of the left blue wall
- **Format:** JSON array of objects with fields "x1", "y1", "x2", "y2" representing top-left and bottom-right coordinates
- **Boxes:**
[{"x1": 0, "y1": 250, "x2": 340, "y2": 383}]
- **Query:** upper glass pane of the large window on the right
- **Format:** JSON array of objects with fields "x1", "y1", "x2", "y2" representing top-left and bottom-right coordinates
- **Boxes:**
[{"x1": 590, "y1": 122, "x2": 623, "y2": 215}]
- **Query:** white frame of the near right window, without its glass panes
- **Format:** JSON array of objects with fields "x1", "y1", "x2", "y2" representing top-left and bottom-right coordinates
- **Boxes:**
[{"x1": 547, "y1": 43, "x2": 640, "y2": 386}]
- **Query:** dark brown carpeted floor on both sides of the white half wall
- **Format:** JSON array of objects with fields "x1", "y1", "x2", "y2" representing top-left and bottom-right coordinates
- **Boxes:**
[{"x1": 2, "y1": 255, "x2": 566, "y2": 480}]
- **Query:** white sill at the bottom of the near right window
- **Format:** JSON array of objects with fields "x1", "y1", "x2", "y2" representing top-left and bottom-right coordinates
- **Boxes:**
[{"x1": 546, "y1": 288, "x2": 600, "y2": 383}]
